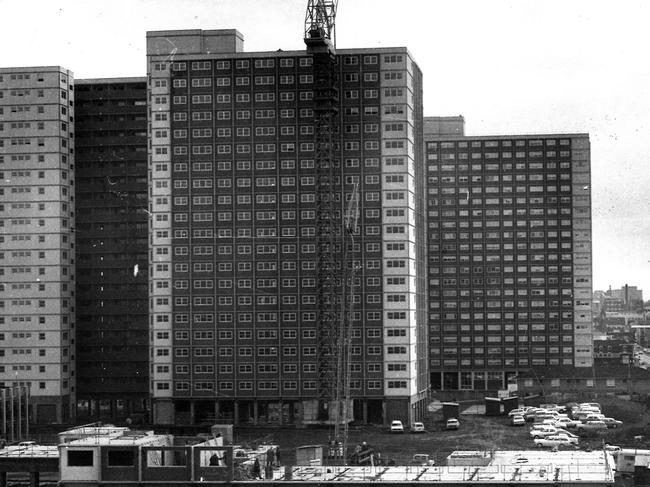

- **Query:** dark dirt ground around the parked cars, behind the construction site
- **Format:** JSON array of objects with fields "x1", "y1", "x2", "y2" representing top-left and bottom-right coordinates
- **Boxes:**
[{"x1": 235, "y1": 398, "x2": 650, "y2": 465}]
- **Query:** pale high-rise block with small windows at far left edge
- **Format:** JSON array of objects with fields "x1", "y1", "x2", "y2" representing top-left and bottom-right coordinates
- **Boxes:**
[{"x1": 0, "y1": 67, "x2": 75, "y2": 422}]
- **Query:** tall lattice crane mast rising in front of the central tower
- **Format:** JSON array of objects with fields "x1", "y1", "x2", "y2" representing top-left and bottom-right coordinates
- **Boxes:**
[{"x1": 304, "y1": 0, "x2": 356, "y2": 456}]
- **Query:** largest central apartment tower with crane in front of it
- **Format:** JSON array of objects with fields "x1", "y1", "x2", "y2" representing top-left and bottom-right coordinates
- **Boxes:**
[{"x1": 147, "y1": 30, "x2": 428, "y2": 423}]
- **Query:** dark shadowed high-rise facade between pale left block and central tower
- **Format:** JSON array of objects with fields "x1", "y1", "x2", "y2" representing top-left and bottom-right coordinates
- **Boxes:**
[{"x1": 75, "y1": 78, "x2": 149, "y2": 421}]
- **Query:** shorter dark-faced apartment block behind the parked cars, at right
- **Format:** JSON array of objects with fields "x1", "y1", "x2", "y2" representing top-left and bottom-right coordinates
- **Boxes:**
[{"x1": 425, "y1": 127, "x2": 593, "y2": 390}]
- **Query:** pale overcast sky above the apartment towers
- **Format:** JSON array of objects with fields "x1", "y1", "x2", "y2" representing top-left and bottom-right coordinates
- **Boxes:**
[{"x1": 0, "y1": 0, "x2": 650, "y2": 300}]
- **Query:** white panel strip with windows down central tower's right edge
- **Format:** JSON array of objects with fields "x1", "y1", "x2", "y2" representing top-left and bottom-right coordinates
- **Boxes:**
[{"x1": 380, "y1": 51, "x2": 417, "y2": 396}]
